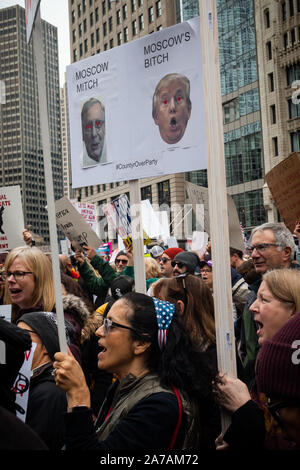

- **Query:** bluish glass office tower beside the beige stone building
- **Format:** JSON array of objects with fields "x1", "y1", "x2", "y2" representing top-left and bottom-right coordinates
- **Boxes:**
[{"x1": 177, "y1": 0, "x2": 266, "y2": 231}]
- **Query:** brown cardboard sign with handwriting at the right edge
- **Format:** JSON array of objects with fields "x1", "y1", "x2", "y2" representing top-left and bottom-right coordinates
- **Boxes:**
[{"x1": 265, "y1": 152, "x2": 300, "y2": 233}]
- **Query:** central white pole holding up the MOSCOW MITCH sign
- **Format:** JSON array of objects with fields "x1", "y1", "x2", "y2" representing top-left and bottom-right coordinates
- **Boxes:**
[{"x1": 129, "y1": 180, "x2": 146, "y2": 294}]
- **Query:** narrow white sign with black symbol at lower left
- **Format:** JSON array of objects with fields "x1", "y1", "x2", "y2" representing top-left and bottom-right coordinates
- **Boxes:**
[{"x1": 13, "y1": 343, "x2": 37, "y2": 423}]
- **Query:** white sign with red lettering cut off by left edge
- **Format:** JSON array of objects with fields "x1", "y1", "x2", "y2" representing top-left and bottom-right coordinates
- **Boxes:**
[{"x1": 0, "y1": 186, "x2": 24, "y2": 251}]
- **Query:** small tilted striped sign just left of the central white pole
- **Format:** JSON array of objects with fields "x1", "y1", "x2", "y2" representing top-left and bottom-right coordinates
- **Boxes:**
[{"x1": 102, "y1": 194, "x2": 152, "y2": 247}]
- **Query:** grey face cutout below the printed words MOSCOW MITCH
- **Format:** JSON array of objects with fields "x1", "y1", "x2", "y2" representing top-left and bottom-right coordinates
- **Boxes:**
[{"x1": 81, "y1": 98, "x2": 107, "y2": 168}]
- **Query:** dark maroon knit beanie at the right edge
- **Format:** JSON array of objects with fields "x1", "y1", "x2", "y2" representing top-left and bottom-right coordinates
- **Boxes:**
[{"x1": 256, "y1": 313, "x2": 300, "y2": 403}]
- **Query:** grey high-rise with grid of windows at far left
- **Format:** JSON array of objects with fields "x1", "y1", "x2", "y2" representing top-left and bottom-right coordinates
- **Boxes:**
[{"x1": 0, "y1": 6, "x2": 62, "y2": 243}]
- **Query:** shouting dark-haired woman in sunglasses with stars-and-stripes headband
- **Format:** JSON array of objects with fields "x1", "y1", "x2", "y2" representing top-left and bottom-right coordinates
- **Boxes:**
[{"x1": 54, "y1": 292, "x2": 217, "y2": 452}]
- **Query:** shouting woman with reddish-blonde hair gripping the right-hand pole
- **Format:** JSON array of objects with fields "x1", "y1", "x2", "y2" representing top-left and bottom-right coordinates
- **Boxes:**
[{"x1": 215, "y1": 269, "x2": 300, "y2": 450}]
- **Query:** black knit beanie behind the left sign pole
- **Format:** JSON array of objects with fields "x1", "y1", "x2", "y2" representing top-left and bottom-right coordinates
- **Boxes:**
[{"x1": 18, "y1": 312, "x2": 74, "y2": 361}]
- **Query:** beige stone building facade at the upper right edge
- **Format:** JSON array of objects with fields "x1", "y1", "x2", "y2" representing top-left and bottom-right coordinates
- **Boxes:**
[{"x1": 254, "y1": 0, "x2": 300, "y2": 221}]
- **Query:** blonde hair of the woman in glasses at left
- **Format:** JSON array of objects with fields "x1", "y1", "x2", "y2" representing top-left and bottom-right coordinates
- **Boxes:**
[{"x1": 4, "y1": 246, "x2": 55, "y2": 319}]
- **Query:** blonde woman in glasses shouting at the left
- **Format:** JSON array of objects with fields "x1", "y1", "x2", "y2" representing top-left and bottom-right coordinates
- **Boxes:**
[{"x1": 2, "y1": 246, "x2": 90, "y2": 361}]
